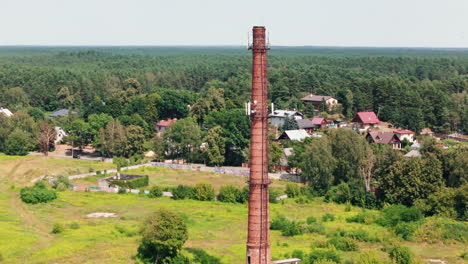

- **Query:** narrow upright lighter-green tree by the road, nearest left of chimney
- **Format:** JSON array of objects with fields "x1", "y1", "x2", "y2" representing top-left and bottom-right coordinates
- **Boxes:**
[{"x1": 203, "y1": 126, "x2": 225, "y2": 166}]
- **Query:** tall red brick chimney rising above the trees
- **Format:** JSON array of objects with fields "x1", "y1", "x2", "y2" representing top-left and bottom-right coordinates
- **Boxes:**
[{"x1": 246, "y1": 27, "x2": 271, "y2": 264}]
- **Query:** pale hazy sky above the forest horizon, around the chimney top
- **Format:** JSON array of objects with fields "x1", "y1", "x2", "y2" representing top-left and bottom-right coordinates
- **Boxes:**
[{"x1": 0, "y1": 0, "x2": 468, "y2": 48}]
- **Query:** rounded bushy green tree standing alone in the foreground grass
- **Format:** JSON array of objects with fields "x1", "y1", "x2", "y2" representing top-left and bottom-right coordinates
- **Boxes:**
[{"x1": 137, "y1": 210, "x2": 188, "y2": 264}]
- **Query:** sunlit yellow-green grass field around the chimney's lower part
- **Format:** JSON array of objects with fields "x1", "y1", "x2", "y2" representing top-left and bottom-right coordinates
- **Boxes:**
[{"x1": 0, "y1": 156, "x2": 466, "y2": 264}]
